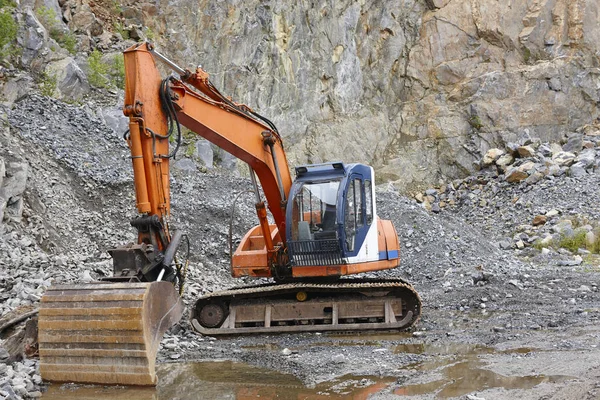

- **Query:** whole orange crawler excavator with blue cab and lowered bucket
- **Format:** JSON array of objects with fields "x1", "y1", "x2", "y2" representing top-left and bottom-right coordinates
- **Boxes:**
[{"x1": 38, "y1": 42, "x2": 421, "y2": 385}]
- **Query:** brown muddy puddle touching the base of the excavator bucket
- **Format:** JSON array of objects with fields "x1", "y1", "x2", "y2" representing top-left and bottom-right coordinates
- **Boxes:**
[{"x1": 42, "y1": 361, "x2": 396, "y2": 400}]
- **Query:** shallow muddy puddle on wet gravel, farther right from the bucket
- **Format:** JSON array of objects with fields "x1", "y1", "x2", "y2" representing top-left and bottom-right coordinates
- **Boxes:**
[{"x1": 394, "y1": 343, "x2": 573, "y2": 398}]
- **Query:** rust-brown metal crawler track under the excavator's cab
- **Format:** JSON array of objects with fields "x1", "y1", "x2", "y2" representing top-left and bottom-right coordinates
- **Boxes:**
[{"x1": 191, "y1": 279, "x2": 421, "y2": 335}]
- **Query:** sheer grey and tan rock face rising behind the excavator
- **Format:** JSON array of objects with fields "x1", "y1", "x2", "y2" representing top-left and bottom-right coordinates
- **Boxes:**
[{"x1": 108, "y1": 0, "x2": 600, "y2": 189}]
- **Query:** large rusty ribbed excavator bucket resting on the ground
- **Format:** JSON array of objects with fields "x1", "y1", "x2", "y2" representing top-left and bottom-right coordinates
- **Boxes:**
[{"x1": 38, "y1": 282, "x2": 183, "y2": 385}]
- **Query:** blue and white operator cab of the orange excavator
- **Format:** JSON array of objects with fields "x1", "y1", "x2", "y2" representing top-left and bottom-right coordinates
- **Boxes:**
[{"x1": 286, "y1": 162, "x2": 378, "y2": 267}]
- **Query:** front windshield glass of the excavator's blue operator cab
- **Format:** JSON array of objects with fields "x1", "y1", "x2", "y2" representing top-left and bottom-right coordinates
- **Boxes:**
[{"x1": 292, "y1": 179, "x2": 341, "y2": 240}]
